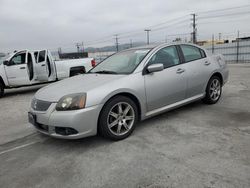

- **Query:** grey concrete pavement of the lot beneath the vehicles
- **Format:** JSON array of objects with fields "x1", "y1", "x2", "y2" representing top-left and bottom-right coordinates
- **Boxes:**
[{"x1": 0, "y1": 64, "x2": 250, "y2": 188}]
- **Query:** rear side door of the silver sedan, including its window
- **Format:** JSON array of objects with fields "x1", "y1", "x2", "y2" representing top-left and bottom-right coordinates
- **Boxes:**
[{"x1": 180, "y1": 44, "x2": 212, "y2": 98}]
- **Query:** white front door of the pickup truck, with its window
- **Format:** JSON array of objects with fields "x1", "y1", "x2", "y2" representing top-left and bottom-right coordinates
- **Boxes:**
[{"x1": 4, "y1": 51, "x2": 30, "y2": 86}]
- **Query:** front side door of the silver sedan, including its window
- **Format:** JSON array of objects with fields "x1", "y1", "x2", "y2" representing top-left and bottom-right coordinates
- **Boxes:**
[{"x1": 145, "y1": 46, "x2": 187, "y2": 112}]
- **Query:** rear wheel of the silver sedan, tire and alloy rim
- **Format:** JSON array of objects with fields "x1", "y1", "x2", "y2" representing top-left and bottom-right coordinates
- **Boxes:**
[{"x1": 202, "y1": 76, "x2": 222, "y2": 104}]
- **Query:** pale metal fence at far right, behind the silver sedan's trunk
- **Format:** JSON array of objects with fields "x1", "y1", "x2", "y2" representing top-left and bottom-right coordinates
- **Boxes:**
[{"x1": 204, "y1": 41, "x2": 250, "y2": 63}]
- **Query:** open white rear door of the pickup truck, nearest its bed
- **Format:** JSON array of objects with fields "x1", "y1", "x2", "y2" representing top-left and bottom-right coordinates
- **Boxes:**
[{"x1": 34, "y1": 50, "x2": 49, "y2": 81}]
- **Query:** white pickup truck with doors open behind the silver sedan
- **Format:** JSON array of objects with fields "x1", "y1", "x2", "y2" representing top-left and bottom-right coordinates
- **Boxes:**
[{"x1": 0, "y1": 50, "x2": 95, "y2": 97}]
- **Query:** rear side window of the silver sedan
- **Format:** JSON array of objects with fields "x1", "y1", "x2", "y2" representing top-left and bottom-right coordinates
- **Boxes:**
[{"x1": 181, "y1": 45, "x2": 202, "y2": 62}]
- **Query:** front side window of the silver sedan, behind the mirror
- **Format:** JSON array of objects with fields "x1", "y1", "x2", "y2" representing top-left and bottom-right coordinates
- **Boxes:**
[{"x1": 149, "y1": 46, "x2": 180, "y2": 68}]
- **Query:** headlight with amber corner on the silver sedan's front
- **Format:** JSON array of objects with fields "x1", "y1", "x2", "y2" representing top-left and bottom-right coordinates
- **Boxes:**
[{"x1": 56, "y1": 93, "x2": 86, "y2": 111}]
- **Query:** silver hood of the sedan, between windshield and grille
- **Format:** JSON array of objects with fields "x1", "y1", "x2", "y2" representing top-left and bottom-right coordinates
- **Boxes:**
[{"x1": 35, "y1": 74, "x2": 125, "y2": 102}]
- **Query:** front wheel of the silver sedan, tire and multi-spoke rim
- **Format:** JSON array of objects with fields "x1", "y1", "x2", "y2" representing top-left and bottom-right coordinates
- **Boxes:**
[{"x1": 98, "y1": 96, "x2": 138, "y2": 140}]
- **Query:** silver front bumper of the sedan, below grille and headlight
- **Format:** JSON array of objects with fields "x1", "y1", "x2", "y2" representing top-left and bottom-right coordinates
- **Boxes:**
[{"x1": 29, "y1": 103, "x2": 102, "y2": 139}]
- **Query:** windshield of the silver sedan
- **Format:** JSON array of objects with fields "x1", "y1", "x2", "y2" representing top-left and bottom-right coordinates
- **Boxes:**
[{"x1": 89, "y1": 49, "x2": 150, "y2": 74}]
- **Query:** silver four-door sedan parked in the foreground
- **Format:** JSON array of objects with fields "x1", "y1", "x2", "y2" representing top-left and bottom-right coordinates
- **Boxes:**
[{"x1": 28, "y1": 44, "x2": 228, "y2": 140}]
